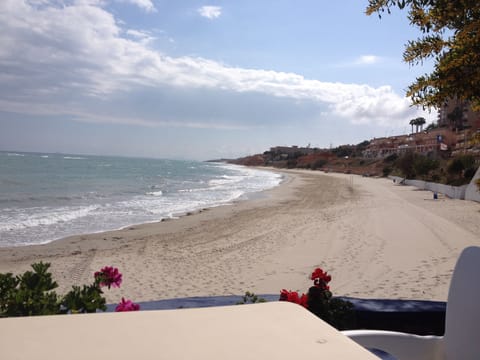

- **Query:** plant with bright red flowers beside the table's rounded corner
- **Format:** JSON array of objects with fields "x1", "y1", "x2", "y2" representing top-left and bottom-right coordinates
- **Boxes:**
[{"x1": 279, "y1": 268, "x2": 355, "y2": 330}]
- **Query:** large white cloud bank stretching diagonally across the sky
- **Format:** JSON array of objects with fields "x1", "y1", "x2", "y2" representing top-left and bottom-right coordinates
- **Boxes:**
[{"x1": 0, "y1": 0, "x2": 428, "y2": 127}]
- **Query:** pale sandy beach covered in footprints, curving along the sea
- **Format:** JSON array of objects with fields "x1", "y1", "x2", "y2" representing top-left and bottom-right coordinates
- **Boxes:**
[{"x1": 0, "y1": 171, "x2": 480, "y2": 303}]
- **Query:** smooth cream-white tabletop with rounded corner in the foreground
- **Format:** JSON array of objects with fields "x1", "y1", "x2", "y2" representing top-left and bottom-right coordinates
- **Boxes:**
[{"x1": 0, "y1": 302, "x2": 378, "y2": 360}]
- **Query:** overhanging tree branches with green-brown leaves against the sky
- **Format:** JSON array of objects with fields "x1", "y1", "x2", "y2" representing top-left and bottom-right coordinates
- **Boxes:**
[{"x1": 366, "y1": 0, "x2": 480, "y2": 109}]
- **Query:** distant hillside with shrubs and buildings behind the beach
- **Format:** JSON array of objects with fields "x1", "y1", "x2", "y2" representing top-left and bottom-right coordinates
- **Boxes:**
[{"x1": 226, "y1": 140, "x2": 480, "y2": 185}]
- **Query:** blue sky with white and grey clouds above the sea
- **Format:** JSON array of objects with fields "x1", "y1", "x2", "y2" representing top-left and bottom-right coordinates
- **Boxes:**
[{"x1": 0, "y1": 0, "x2": 436, "y2": 160}]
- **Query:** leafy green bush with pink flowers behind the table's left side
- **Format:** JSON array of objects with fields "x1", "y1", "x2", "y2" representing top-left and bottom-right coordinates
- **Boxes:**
[{"x1": 0, "y1": 262, "x2": 139, "y2": 317}]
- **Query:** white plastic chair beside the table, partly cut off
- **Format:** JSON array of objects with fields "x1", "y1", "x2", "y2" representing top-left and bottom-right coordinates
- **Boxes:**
[{"x1": 343, "y1": 246, "x2": 480, "y2": 360}]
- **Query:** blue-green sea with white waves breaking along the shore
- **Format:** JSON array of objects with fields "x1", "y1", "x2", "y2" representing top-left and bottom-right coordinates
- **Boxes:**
[{"x1": 0, "y1": 151, "x2": 282, "y2": 247}]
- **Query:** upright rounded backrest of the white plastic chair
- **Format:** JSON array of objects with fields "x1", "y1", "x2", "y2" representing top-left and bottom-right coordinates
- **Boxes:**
[{"x1": 444, "y1": 246, "x2": 480, "y2": 360}]
